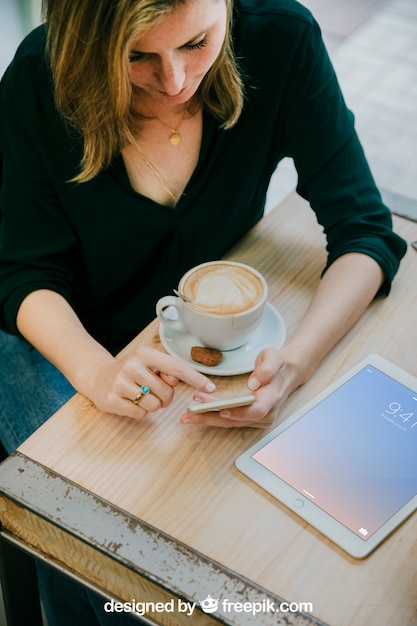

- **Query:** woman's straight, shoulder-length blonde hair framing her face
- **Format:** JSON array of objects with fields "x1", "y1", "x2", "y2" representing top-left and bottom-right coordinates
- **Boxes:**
[{"x1": 43, "y1": 0, "x2": 243, "y2": 182}]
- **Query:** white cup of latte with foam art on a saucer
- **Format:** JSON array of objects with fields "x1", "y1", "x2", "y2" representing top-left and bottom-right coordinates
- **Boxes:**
[{"x1": 156, "y1": 261, "x2": 268, "y2": 351}]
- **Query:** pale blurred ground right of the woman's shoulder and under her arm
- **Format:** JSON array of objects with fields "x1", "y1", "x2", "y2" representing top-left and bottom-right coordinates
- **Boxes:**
[{"x1": 268, "y1": 0, "x2": 417, "y2": 220}]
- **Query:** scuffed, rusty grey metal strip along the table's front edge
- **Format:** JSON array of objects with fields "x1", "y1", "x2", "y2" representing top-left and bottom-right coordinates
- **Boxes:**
[{"x1": 0, "y1": 452, "x2": 327, "y2": 626}]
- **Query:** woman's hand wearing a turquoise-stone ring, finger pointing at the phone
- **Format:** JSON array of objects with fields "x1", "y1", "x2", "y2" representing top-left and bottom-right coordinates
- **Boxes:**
[{"x1": 80, "y1": 346, "x2": 215, "y2": 419}]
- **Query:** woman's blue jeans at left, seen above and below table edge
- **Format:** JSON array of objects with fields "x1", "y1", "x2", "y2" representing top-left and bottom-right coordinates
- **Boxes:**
[{"x1": 0, "y1": 330, "x2": 143, "y2": 626}]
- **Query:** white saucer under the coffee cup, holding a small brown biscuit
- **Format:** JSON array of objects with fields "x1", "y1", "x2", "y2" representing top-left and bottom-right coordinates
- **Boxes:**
[{"x1": 159, "y1": 302, "x2": 286, "y2": 376}]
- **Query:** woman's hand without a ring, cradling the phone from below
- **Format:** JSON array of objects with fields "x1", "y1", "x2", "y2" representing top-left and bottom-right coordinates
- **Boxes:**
[{"x1": 181, "y1": 348, "x2": 298, "y2": 428}]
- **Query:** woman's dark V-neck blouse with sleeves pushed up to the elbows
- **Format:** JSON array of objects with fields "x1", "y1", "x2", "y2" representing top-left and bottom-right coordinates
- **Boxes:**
[{"x1": 0, "y1": 0, "x2": 406, "y2": 349}]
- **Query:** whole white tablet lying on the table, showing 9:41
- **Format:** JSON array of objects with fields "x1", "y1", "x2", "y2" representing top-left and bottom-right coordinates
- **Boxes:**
[{"x1": 236, "y1": 355, "x2": 417, "y2": 558}]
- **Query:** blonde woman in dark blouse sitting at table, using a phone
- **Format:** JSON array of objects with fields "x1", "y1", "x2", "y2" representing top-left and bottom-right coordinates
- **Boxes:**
[{"x1": 0, "y1": 0, "x2": 406, "y2": 623}]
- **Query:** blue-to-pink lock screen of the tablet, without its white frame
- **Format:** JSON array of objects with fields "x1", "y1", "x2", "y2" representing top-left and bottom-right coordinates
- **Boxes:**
[{"x1": 252, "y1": 365, "x2": 417, "y2": 541}]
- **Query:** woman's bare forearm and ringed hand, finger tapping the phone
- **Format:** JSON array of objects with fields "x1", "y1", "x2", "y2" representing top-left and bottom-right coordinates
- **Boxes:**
[{"x1": 17, "y1": 289, "x2": 215, "y2": 419}]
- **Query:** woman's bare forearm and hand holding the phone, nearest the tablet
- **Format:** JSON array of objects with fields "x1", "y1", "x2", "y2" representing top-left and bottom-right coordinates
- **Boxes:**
[{"x1": 181, "y1": 253, "x2": 384, "y2": 427}]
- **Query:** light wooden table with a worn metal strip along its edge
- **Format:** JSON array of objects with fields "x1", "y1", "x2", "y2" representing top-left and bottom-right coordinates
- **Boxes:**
[{"x1": 0, "y1": 194, "x2": 417, "y2": 626}]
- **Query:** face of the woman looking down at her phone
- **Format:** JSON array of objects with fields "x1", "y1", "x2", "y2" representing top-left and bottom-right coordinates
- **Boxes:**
[{"x1": 129, "y1": 0, "x2": 228, "y2": 107}]
